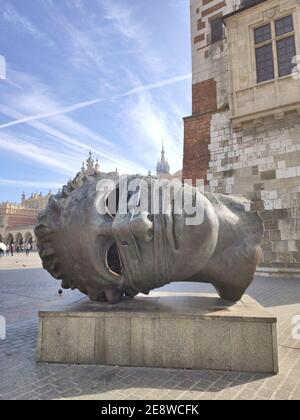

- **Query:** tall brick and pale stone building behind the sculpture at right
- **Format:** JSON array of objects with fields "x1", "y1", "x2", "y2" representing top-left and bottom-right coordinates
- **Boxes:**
[{"x1": 183, "y1": 0, "x2": 300, "y2": 272}]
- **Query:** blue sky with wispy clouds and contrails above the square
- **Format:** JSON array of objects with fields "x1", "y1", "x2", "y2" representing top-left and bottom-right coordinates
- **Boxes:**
[{"x1": 0, "y1": 0, "x2": 191, "y2": 202}]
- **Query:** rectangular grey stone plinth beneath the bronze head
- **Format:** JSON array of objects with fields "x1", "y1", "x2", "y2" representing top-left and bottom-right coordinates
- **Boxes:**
[{"x1": 38, "y1": 293, "x2": 278, "y2": 373}]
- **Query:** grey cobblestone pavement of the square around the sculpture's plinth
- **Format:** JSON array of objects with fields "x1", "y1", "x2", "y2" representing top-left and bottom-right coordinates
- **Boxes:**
[{"x1": 0, "y1": 255, "x2": 300, "y2": 400}]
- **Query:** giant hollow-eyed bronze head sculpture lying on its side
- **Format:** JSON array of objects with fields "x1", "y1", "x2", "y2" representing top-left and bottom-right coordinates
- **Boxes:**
[{"x1": 35, "y1": 172, "x2": 264, "y2": 303}]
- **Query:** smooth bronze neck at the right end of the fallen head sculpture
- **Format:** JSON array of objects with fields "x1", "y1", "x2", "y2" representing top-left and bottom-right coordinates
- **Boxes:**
[{"x1": 201, "y1": 195, "x2": 264, "y2": 301}]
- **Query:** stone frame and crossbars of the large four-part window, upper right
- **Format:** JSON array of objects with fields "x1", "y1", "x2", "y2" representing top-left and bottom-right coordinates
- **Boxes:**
[{"x1": 251, "y1": 11, "x2": 298, "y2": 86}]
